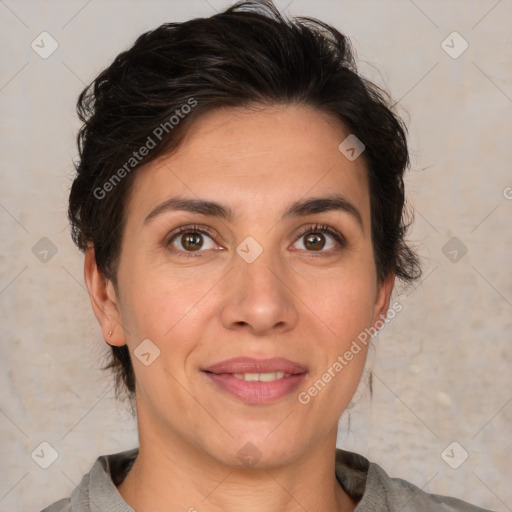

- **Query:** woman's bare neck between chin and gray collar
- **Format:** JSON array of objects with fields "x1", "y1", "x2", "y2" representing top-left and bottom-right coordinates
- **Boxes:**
[{"x1": 118, "y1": 439, "x2": 356, "y2": 512}]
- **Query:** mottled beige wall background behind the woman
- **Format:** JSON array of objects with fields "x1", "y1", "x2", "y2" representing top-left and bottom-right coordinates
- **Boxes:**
[{"x1": 0, "y1": 0, "x2": 512, "y2": 511}]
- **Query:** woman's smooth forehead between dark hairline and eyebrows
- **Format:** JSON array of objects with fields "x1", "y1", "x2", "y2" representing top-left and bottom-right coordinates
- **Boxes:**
[{"x1": 126, "y1": 106, "x2": 369, "y2": 222}]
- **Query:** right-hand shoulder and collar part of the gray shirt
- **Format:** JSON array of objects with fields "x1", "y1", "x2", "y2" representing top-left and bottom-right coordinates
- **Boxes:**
[{"x1": 336, "y1": 450, "x2": 491, "y2": 512}]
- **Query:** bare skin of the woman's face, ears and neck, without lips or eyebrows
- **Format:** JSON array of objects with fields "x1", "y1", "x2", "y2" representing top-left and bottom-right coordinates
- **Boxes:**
[{"x1": 85, "y1": 106, "x2": 394, "y2": 512}]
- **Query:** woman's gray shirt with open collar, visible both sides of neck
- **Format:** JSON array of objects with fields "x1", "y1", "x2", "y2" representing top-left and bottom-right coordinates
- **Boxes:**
[{"x1": 42, "y1": 448, "x2": 496, "y2": 512}]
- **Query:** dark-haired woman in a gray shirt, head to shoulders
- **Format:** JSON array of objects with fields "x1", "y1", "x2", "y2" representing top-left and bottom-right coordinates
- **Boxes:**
[{"x1": 41, "y1": 2, "x2": 496, "y2": 512}]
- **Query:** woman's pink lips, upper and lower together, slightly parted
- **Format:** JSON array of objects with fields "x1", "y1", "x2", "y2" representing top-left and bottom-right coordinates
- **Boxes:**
[{"x1": 203, "y1": 357, "x2": 308, "y2": 405}]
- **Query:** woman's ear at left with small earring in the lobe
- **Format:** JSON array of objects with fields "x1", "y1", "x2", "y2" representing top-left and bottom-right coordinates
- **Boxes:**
[{"x1": 84, "y1": 247, "x2": 126, "y2": 347}]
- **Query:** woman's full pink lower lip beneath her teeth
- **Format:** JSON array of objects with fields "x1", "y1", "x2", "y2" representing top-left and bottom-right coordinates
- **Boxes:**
[{"x1": 205, "y1": 372, "x2": 306, "y2": 404}]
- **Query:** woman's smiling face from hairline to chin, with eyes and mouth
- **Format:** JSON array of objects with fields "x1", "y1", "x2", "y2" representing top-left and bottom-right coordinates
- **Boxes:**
[{"x1": 89, "y1": 106, "x2": 393, "y2": 466}]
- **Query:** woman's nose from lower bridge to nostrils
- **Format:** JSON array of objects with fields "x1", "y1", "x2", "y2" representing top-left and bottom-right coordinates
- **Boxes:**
[{"x1": 221, "y1": 250, "x2": 298, "y2": 336}]
